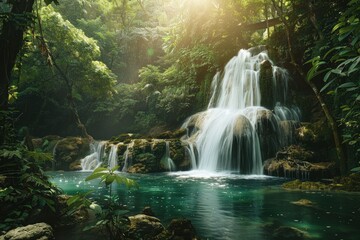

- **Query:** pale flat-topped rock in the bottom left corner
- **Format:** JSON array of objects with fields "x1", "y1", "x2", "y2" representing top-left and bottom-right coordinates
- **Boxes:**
[{"x1": 0, "y1": 223, "x2": 54, "y2": 240}]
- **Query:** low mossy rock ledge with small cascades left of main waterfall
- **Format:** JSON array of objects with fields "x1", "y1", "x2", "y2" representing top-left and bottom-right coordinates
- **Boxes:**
[{"x1": 81, "y1": 139, "x2": 186, "y2": 173}]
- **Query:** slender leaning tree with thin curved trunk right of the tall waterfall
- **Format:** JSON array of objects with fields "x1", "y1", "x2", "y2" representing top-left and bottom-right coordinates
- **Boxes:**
[{"x1": 272, "y1": 0, "x2": 347, "y2": 174}]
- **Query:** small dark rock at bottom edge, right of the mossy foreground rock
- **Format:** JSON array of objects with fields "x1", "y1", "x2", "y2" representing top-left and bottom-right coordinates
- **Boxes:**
[{"x1": 167, "y1": 218, "x2": 197, "y2": 240}]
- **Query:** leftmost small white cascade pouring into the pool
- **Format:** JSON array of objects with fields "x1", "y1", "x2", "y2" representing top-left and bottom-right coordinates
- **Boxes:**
[{"x1": 81, "y1": 141, "x2": 106, "y2": 171}]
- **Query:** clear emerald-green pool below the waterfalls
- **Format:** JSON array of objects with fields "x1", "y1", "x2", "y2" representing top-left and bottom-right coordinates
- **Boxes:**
[{"x1": 48, "y1": 172, "x2": 360, "y2": 240}]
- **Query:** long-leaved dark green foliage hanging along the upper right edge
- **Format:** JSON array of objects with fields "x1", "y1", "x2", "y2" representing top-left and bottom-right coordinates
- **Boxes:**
[{"x1": 308, "y1": 0, "x2": 360, "y2": 159}]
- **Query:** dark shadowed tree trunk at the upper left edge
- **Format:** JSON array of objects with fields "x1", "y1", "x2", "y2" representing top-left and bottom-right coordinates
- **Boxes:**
[{"x1": 0, "y1": 0, "x2": 35, "y2": 145}]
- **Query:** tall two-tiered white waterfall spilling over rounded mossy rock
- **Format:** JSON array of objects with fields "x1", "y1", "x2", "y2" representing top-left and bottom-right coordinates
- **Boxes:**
[{"x1": 182, "y1": 49, "x2": 300, "y2": 174}]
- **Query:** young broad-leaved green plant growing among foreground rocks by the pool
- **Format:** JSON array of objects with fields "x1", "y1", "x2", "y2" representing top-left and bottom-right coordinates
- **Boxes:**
[{"x1": 83, "y1": 166, "x2": 138, "y2": 239}]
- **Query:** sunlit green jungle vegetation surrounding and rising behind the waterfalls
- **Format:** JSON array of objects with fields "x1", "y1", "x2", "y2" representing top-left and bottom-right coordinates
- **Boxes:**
[{"x1": 0, "y1": 0, "x2": 360, "y2": 233}]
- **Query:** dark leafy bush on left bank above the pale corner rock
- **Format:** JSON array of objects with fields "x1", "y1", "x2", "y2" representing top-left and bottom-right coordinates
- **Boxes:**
[{"x1": 0, "y1": 145, "x2": 60, "y2": 230}]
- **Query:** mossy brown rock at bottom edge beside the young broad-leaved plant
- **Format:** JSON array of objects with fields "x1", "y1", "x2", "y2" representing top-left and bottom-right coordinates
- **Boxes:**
[{"x1": 126, "y1": 214, "x2": 165, "y2": 240}]
